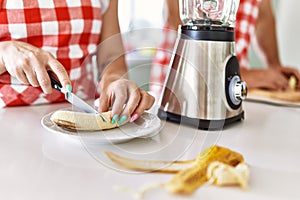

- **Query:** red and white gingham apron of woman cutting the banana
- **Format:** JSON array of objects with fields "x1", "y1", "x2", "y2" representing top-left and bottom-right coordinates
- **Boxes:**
[{"x1": 0, "y1": 0, "x2": 109, "y2": 107}]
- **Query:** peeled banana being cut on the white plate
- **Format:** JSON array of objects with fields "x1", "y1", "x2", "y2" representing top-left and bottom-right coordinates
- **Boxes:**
[{"x1": 50, "y1": 110, "x2": 119, "y2": 131}]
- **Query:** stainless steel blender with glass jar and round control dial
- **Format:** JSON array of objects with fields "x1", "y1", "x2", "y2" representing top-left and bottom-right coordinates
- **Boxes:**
[{"x1": 158, "y1": 0, "x2": 247, "y2": 130}]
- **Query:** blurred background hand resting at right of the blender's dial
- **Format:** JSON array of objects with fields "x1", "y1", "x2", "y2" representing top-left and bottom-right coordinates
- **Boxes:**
[{"x1": 241, "y1": 67, "x2": 300, "y2": 91}]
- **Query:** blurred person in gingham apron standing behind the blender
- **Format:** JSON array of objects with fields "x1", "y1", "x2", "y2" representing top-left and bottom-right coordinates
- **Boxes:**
[{"x1": 150, "y1": 0, "x2": 300, "y2": 95}]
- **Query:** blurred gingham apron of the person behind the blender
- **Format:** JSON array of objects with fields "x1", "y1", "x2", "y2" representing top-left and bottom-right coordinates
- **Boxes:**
[{"x1": 150, "y1": 0, "x2": 260, "y2": 95}]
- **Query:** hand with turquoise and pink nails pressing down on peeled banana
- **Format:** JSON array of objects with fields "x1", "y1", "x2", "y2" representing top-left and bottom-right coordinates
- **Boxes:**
[{"x1": 99, "y1": 79, "x2": 154, "y2": 124}]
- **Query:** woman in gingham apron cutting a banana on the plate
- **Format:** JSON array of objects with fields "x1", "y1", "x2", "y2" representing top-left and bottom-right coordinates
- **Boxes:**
[{"x1": 0, "y1": 0, "x2": 154, "y2": 124}]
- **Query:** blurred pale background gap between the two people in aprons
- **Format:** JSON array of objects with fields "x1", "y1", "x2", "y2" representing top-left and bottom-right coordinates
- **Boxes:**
[{"x1": 119, "y1": 0, "x2": 165, "y2": 90}]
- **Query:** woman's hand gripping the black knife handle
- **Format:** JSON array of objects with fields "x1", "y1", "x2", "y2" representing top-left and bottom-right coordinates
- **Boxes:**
[{"x1": 0, "y1": 41, "x2": 71, "y2": 94}]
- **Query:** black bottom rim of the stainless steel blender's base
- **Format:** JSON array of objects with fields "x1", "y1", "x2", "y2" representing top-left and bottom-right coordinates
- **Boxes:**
[{"x1": 158, "y1": 109, "x2": 244, "y2": 130}]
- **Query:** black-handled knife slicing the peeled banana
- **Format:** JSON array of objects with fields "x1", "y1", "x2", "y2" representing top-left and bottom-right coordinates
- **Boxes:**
[{"x1": 48, "y1": 71, "x2": 108, "y2": 122}]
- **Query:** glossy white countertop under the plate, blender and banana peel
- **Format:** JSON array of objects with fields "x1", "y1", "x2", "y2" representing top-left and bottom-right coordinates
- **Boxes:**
[{"x1": 0, "y1": 102, "x2": 300, "y2": 200}]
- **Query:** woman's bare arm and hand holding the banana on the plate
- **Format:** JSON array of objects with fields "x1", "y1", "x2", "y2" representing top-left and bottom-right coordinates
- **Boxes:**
[{"x1": 98, "y1": 0, "x2": 154, "y2": 124}]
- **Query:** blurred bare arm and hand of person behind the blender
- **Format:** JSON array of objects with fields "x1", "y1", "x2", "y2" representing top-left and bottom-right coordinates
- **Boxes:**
[{"x1": 241, "y1": 0, "x2": 300, "y2": 90}]
